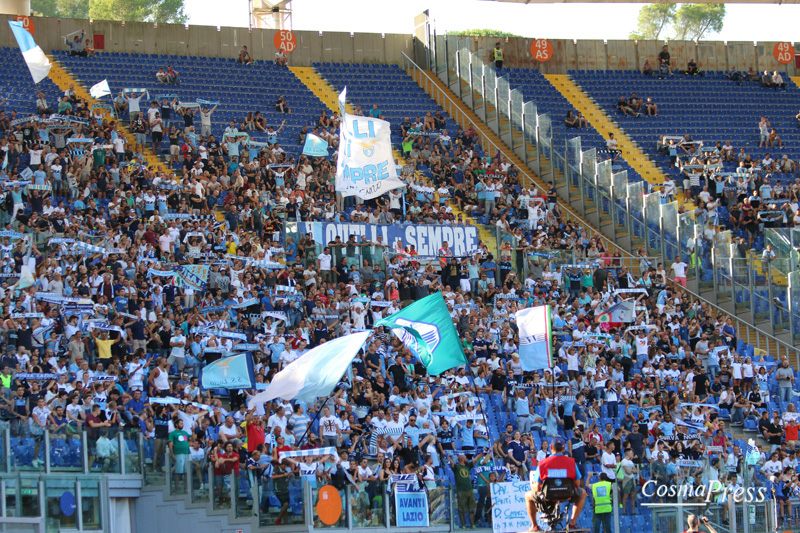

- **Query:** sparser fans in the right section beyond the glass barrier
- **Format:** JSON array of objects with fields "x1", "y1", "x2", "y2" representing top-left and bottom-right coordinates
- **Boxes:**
[{"x1": 632, "y1": 46, "x2": 800, "y2": 251}]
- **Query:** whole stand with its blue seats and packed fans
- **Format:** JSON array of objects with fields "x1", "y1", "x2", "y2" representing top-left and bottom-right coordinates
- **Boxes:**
[{"x1": 0, "y1": 25, "x2": 800, "y2": 530}]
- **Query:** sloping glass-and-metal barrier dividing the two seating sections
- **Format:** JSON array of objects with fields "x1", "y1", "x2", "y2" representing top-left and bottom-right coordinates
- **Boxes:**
[{"x1": 418, "y1": 36, "x2": 800, "y2": 362}]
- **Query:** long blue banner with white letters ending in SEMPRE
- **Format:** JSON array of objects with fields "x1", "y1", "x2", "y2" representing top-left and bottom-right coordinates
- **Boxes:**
[{"x1": 297, "y1": 222, "x2": 478, "y2": 257}]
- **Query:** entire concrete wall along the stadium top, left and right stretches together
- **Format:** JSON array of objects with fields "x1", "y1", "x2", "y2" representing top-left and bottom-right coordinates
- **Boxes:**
[{"x1": 0, "y1": 14, "x2": 797, "y2": 75}]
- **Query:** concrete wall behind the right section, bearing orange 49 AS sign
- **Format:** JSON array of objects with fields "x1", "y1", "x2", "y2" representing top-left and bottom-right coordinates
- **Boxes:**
[{"x1": 450, "y1": 37, "x2": 799, "y2": 76}]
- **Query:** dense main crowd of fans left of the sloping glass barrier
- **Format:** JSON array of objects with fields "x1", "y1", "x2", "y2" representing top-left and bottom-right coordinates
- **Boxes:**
[{"x1": 0, "y1": 45, "x2": 798, "y2": 527}]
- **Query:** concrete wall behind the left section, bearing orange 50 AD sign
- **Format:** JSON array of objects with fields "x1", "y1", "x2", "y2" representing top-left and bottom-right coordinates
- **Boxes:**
[{"x1": 0, "y1": 17, "x2": 414, "y2": 67}]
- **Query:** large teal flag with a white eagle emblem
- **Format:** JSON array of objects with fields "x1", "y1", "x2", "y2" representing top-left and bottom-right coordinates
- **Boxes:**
[{"x1": 375, "y1": 292, "x2": 467, "y2": 376}]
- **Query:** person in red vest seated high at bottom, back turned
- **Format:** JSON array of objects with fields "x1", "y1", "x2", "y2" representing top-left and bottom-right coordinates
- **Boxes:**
[{"x1": 525, "y1": 436, "x2": 586, "y2": 531}]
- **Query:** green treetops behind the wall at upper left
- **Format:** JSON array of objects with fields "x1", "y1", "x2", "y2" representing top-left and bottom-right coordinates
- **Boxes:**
[{"x1": 31, "y1": 0, "x2": 188, "y2": 23}]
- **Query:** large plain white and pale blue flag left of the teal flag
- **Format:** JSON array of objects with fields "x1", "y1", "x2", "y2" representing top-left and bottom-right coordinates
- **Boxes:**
[{"x1": 247, "y1": 331, "x2": 370, "y2": 409}]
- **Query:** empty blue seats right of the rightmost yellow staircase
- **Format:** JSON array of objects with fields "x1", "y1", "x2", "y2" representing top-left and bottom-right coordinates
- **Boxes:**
[{"x1": 564, "y1": 70, "x2": 800, "y2": 224}]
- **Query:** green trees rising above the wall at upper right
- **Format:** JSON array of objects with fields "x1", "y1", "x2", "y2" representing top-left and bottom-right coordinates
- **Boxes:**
[{"x1": 630, "y1": 4, "x2": 725, "y2": 41}]
